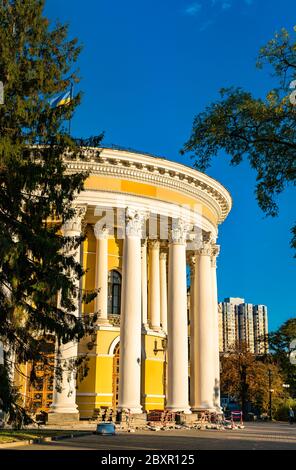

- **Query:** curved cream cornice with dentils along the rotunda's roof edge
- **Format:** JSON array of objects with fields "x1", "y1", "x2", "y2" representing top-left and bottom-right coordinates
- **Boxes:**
[{"x1": 65, "y1": 148, "x2": 232, "y2": 223}]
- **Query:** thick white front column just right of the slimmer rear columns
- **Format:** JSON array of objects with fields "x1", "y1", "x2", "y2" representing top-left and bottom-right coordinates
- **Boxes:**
[{"x1": 167, "y1": 220, "x2": 190, "y2": 413}]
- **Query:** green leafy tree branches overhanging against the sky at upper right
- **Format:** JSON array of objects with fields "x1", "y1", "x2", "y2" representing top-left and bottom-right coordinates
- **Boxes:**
[{"x1": 181, "y1": 26, "x2": 296, "y2": 253}]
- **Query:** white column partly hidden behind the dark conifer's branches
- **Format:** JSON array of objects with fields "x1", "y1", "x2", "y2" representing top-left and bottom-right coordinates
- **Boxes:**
[{"x1": 49, "y1": 207, "x2": 86, "y2": 416}]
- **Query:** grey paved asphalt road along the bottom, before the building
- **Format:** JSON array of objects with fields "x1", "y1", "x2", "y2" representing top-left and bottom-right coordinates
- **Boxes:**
[{"x1": 5, "y1": 423, "x2": 296, "y2": 451}]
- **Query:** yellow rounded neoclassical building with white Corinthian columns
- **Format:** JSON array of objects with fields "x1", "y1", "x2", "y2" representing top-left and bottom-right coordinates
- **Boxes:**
[{"x1": 17, "y1": 148, "x2": 231, "y2": 422}]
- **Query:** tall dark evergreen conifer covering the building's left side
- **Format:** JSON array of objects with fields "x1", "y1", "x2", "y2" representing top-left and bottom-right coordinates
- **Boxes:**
[{"x1": 0, "y1": 0, "x2": 100, "y2": 422}]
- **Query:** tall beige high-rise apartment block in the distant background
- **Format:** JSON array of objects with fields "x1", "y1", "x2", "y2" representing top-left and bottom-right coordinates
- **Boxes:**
[{"x1": 219, "y1": 297, "x2": 268, "y2": 354}]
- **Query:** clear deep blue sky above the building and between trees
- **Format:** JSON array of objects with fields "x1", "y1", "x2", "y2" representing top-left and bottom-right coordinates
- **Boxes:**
[{"x1": 45, "y1": 0, "x2": 296, "y2": 329}]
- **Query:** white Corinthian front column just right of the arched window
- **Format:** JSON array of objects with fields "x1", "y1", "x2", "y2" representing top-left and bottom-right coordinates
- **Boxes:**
[{"x1": 118, "y1": 209, "x2": 144, "y2": 414}]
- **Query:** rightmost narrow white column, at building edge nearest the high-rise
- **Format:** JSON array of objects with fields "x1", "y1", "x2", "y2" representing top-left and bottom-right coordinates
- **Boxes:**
[{"x1": 211, "y1": 245, "x2": 221, "y2": 412}]
